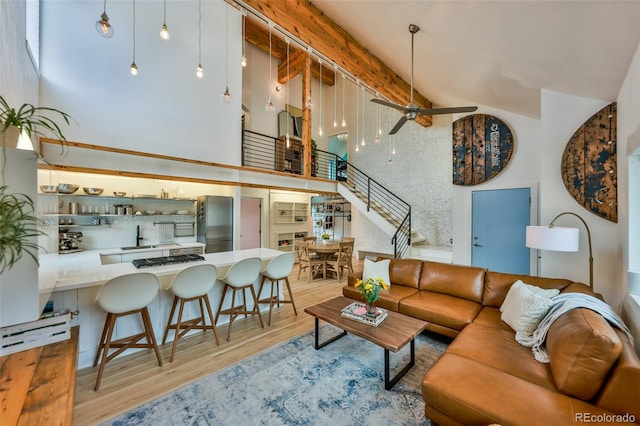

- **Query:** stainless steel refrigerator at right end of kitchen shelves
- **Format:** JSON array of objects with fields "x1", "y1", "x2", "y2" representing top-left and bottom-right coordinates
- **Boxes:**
[{"x1": 197, "y1": 195, "x2": 233, "y2": 253}]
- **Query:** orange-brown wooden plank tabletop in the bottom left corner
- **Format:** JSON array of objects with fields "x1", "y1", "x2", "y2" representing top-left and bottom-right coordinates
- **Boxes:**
[{"x1": 0, "y1": 326, "x2": 79, "y2": 426}]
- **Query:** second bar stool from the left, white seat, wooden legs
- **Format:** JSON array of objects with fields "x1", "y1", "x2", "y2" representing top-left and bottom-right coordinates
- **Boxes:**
[{"x1": 162, "y1": 264, "x2": 220, "y2": 362}]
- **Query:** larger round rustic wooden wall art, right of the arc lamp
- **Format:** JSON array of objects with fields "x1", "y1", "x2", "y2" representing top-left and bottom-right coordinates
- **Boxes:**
[{"x1": 561, "y1": 102, "x2": 618, "y2": 222}]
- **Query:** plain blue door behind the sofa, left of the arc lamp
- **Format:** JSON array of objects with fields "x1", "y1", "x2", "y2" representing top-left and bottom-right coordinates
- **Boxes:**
[{"x1": 471, "y1": 188, "x2": 531, "y2": 275}]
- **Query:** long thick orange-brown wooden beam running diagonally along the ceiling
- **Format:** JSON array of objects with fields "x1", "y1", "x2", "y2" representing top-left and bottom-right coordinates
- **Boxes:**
[{"x1": 243, "y1": 0, "x2": 432, "y2": 126}]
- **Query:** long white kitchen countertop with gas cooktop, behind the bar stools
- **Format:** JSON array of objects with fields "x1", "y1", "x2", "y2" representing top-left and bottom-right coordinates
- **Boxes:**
[{"x1": 38, "y1": 245, "x2": 282, "y2": 293}]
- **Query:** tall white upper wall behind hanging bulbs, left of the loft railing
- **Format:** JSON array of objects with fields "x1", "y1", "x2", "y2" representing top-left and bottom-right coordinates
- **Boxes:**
[{"x1": 38, "y1": 0, "x2": 242, "y2": 165}]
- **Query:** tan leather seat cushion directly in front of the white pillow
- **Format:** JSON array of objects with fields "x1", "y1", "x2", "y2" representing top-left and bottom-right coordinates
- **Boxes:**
[{"x1": 447, "y1": 322, "x2": 558, "y2": 391}]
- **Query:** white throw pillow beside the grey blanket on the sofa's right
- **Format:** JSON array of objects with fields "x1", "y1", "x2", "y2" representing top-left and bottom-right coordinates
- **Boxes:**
[{"x1": 500, "y1": 280, "x2": 559, "y2": 335}]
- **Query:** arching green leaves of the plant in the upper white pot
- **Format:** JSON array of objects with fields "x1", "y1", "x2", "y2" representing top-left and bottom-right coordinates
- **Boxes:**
[{"x1": 0, "y1": 96, "x2": 71, "y2": 144}]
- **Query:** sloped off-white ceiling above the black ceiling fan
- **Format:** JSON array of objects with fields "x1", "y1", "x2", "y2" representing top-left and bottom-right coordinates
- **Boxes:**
[{"x1": 312, "y1": 0, "x2": 640, "y2": 118}]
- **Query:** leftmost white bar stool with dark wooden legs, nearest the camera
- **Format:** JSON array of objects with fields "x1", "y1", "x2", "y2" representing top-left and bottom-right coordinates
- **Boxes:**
[{"x1": 93, "y1": 272, "x2": 162, "y2": 390}]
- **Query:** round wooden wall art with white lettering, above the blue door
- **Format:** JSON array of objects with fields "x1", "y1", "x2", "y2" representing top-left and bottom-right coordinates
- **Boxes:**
[{"x1": 453, "y1": 114, "x2": 513, "y2": 186}]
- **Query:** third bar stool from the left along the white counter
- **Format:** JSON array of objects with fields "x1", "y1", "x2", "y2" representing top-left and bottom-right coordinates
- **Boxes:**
[{"x1": 215, "y1": 257, "x2": 264, "y2": 342}]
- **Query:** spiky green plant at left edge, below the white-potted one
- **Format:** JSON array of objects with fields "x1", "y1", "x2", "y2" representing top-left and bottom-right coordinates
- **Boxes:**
[{"x1": 0, "y1": 185, "x2": 45, "y2": 274}]
